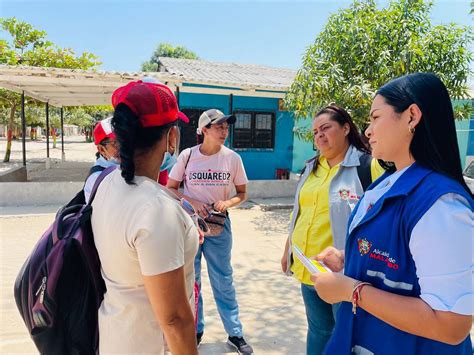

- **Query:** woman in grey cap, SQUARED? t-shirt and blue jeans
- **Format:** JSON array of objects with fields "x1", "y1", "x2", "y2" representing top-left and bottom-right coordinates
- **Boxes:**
[{"x1": 168, "y1": 109, "x2": 253, "y2": 354}]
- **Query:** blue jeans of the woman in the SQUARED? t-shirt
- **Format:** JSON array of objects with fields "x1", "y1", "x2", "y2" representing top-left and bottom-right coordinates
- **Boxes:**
[{"x1": 194, "y1": 217, "x2": 242, "y2": 337}]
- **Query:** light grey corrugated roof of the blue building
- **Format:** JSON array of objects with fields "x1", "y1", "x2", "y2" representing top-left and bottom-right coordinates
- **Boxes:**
[{"x1": 159, "y1": 57, "x2": 296, "y2": 91}]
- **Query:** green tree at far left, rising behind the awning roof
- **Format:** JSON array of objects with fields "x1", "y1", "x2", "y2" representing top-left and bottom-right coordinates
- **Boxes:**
[{"x1": 0, "y1": 17, "x2": 100, "y2": 162}]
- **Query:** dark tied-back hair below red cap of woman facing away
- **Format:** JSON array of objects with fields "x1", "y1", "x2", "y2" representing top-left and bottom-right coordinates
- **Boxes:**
[{"x1": 112, "y1": 104, "x2": 176, "y2": 185}]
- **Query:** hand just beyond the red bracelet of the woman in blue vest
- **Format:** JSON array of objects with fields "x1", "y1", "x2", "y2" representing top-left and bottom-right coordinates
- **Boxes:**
[{"x1": 311, "y1": 272, "x2": 356, "y2": 304}]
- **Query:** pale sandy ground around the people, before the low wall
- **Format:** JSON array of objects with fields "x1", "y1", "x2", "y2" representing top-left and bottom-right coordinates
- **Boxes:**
[{"x1": 0, "y1": 207, "x2": 306, "y2": 354}]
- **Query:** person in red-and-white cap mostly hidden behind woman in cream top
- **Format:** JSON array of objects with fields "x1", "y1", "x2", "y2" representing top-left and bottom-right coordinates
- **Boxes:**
[{"x1": 84, "y1": 117, "x2": 119, "y2": 202}]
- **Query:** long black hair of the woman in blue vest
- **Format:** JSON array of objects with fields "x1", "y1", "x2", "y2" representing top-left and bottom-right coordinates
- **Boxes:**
[{"x1": 376, "y1": 73, "x2": 472, "y2": 195}]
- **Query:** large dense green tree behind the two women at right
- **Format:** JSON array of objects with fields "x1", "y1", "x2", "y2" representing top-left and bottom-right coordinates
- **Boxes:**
[{"x1": 285, "y1": 0, "x2": 472, "y2": 140}]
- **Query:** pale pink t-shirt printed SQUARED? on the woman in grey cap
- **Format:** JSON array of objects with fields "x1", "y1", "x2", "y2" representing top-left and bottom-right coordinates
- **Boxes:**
[{"x1": 170, "y1": 145, "x2": 252, "y2": 204}]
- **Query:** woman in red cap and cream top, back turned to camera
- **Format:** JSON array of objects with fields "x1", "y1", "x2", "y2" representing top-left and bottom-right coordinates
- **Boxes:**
[{"x1": 92, "y1": 81, "x2": 198, "y2": 355}]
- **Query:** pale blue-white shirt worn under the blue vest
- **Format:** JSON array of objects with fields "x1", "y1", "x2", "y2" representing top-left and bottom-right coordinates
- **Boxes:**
[{"x1": 349, "y1": 167, "x2": 474, "y2": 315}]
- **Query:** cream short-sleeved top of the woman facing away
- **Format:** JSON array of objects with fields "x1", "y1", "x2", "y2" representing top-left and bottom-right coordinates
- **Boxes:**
[{"x1": 92, "y1": 170, "x2": 198, "y2": 354}]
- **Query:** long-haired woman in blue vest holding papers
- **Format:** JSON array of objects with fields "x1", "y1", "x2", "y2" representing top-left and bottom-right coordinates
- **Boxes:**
[{"x1": 312, "y1": 73, "x2": 474, "y2": 355}]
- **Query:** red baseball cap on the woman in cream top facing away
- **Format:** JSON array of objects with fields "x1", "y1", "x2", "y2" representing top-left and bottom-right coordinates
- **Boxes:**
[{"x1": 112, "y1": 80, "x2": 189, "y2": 127}]
